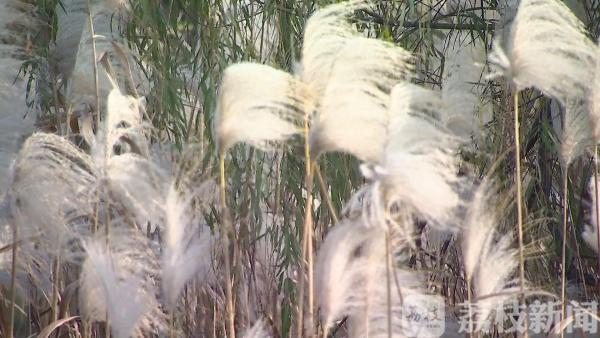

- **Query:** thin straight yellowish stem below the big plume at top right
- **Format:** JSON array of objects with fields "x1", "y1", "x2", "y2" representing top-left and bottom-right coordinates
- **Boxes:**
[{"x1": 514, "y1": 90, "x2": 529, "y2": 337}]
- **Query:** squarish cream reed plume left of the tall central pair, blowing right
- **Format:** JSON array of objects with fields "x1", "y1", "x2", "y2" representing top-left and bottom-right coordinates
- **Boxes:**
[{"x1": 215, "y1": 63, "x2": 313, "y2": 151}]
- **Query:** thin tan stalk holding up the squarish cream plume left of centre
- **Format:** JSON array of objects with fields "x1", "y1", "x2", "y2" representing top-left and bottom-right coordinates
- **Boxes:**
[{"x1": 219, "y1": 151, "x2": 235, "y2": 338}]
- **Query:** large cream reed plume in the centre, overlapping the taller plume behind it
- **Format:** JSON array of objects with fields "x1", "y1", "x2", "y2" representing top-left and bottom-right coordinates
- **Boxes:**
[{"x1": 310, "y1": 37, "x2": 412, "y2": 163}]
